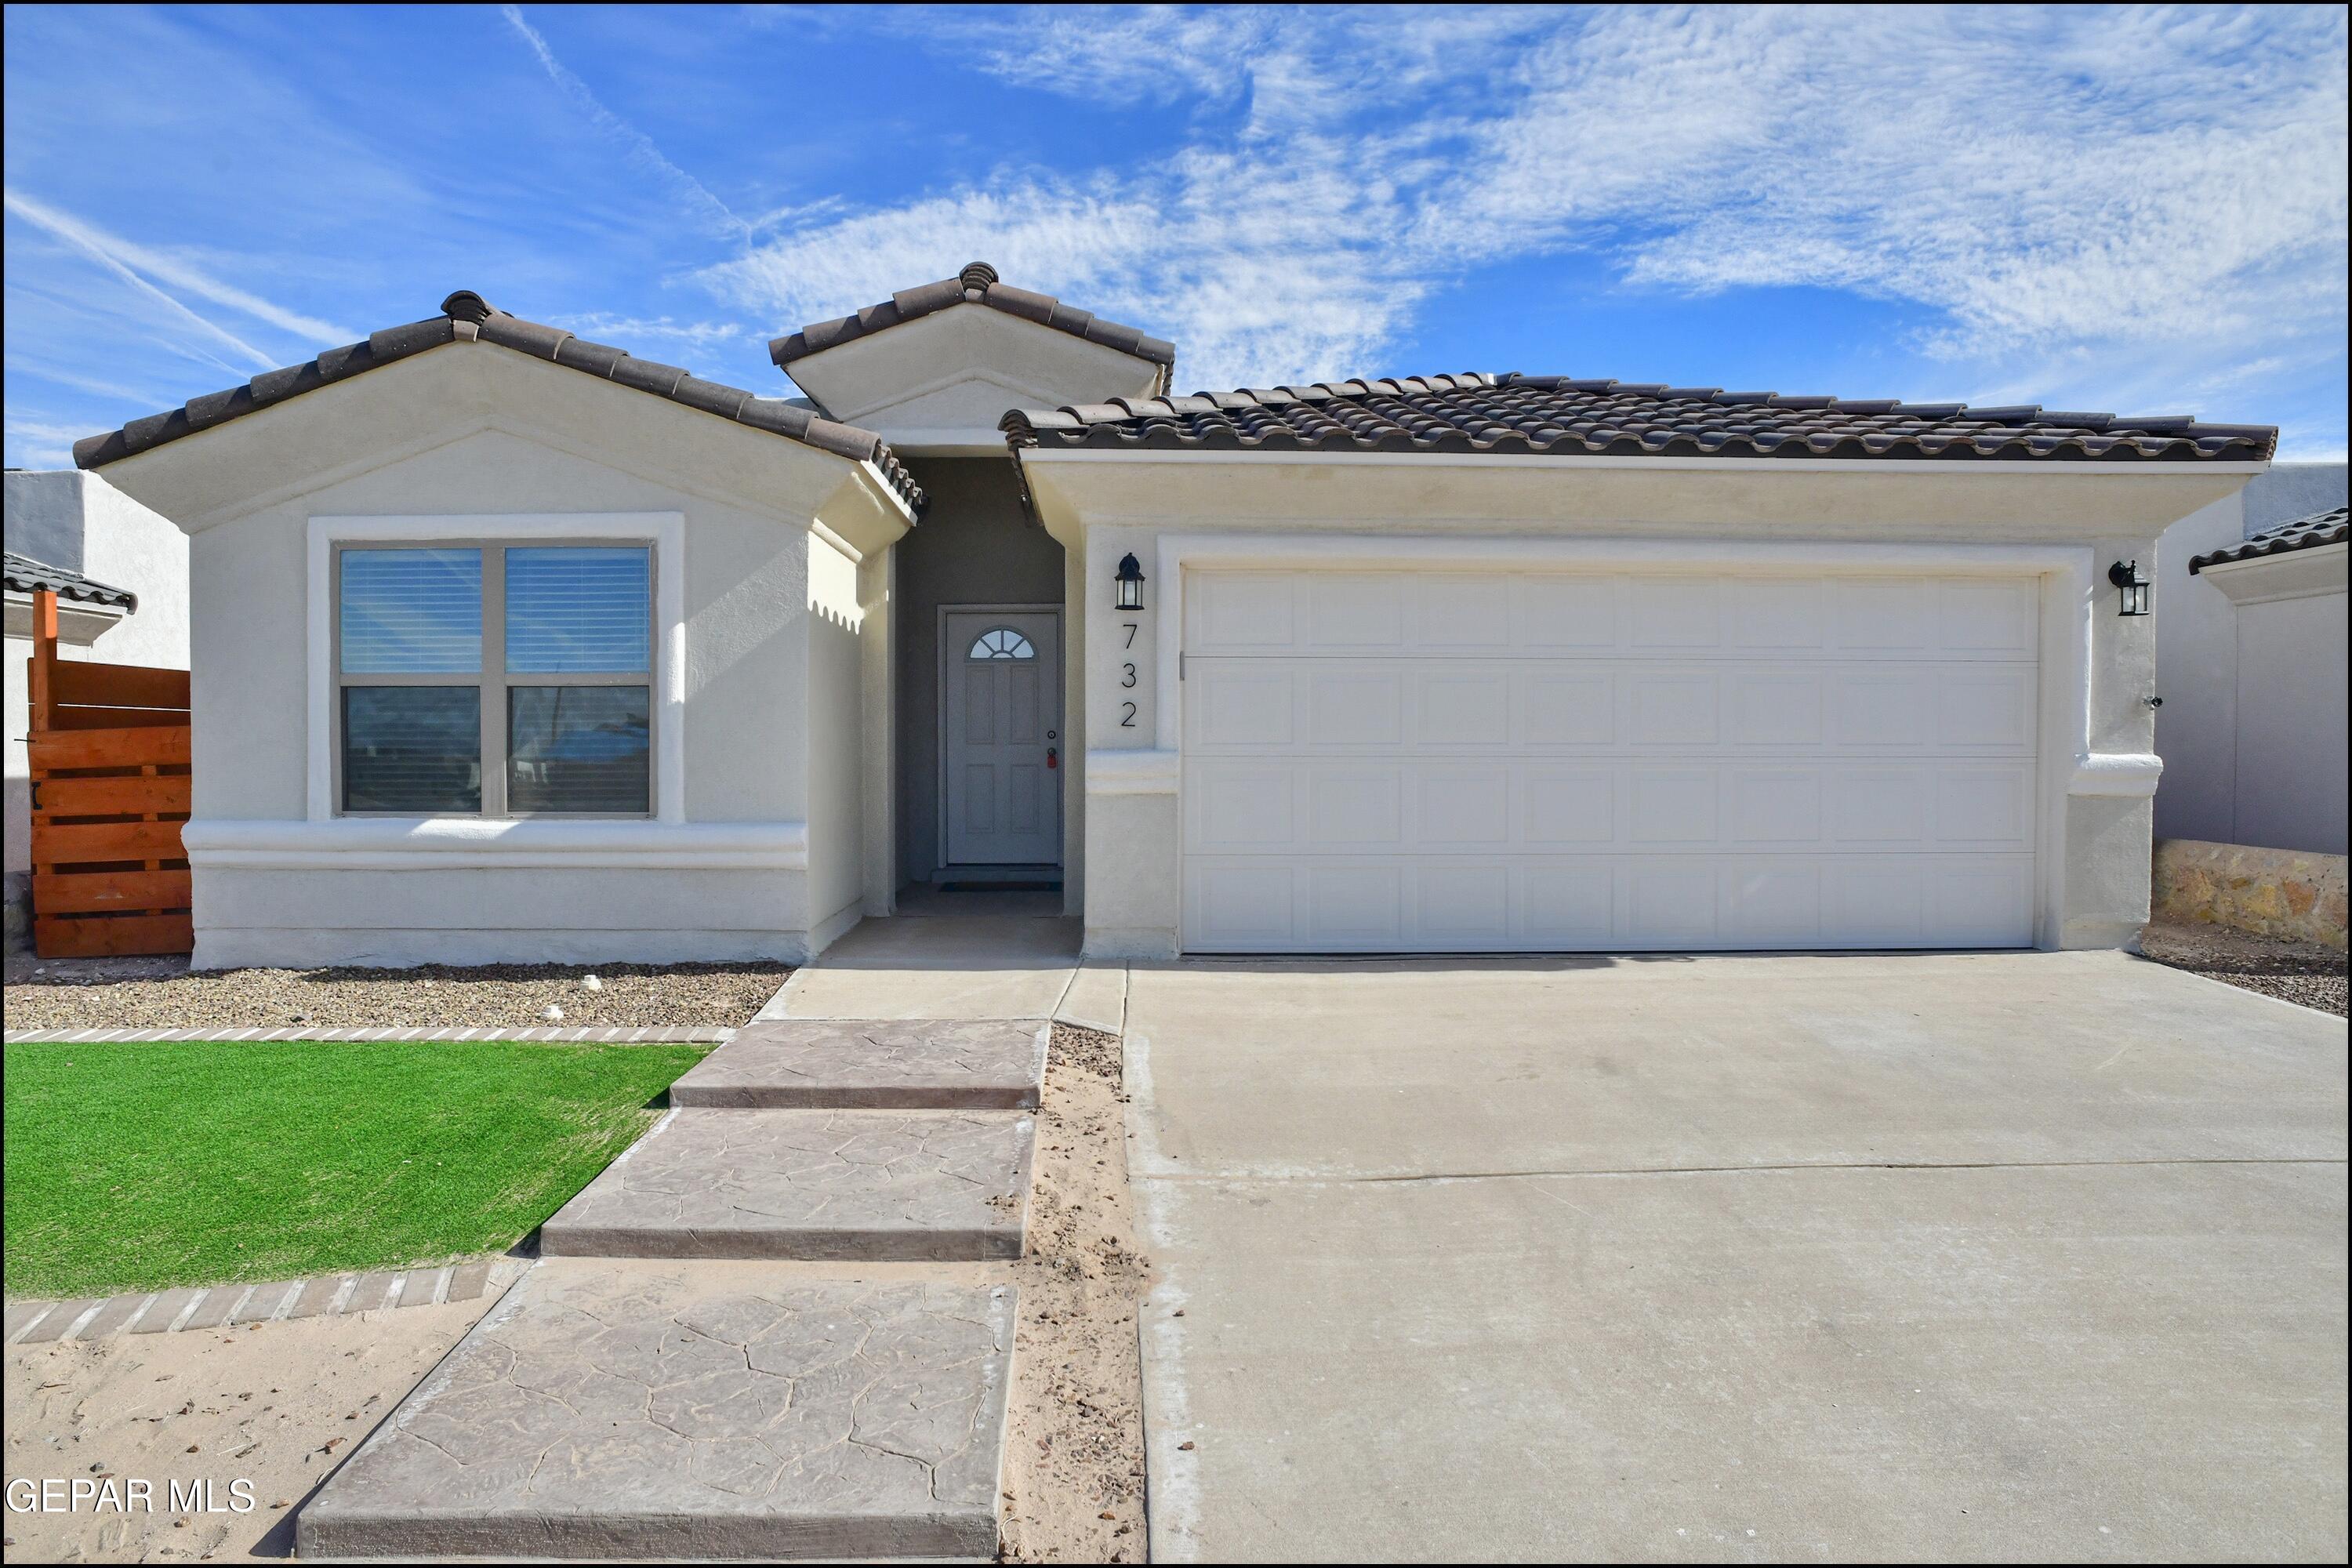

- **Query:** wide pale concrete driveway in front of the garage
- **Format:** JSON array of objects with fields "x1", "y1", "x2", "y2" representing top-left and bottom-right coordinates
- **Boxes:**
[{"x1": 1127, "y1": 952, "x2": 2347, "y2": 1561}]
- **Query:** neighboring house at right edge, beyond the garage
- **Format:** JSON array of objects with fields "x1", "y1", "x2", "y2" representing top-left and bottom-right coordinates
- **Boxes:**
[{"x1": 2157, "y1": 463, "x2": 2345, "y2": 855}]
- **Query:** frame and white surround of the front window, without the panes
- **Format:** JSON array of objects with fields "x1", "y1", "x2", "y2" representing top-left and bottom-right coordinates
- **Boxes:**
[{"x1": 306, "y1": 513, "x2": 687, "y2": 825}]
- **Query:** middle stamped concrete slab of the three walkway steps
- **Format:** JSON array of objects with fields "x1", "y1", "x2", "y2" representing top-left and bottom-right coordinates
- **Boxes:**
[{"x1": 539, "y1": 1107, "x2": 1035, "y2": 1262}]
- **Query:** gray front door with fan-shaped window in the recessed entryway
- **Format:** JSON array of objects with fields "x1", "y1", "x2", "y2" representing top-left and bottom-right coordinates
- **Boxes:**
[{"x1": 938, "y1": 609, "x2": 1063, "y2": 865}]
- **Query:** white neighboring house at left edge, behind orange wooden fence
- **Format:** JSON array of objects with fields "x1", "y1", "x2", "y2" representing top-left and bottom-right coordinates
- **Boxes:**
[{"x1": 0, "y1": 468, "x2": 188, "y2": 945}]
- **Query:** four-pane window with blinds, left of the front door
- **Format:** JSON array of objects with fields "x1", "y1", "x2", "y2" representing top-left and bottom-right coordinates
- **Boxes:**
[{"x1": 334, "y1": 546, "x2": 654, "y2": 815}]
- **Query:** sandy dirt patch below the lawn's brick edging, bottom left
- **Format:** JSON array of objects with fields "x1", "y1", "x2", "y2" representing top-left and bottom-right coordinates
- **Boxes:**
[{"x1": 7, "y1": 1293, "x2": 496, "y2": 1563}]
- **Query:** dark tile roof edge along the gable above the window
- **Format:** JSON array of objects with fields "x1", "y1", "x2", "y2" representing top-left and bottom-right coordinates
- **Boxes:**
[{"x1": 73, "y1": 289, "x2": 924, "y2": 513}]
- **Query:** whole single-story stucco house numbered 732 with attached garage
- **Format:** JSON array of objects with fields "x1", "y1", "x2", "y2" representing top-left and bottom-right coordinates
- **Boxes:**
[{"x1": 75, "y1": 263, "x2": 2277, "y2": 964}]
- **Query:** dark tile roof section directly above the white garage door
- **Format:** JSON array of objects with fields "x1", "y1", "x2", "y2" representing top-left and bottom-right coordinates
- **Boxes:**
[{"x1": 997, "y1": 372, "x2": 2279, "y2": 463}]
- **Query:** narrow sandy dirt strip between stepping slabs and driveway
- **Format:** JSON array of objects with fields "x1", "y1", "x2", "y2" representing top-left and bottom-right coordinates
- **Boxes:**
[{"x1": 1002, "y1": 1025, "x2": 1150, "y2": 1563}]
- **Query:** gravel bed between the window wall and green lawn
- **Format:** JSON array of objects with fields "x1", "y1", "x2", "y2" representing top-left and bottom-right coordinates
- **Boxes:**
[{"x1": 7, "y1": 954, "x2": 793, "y2": 1029}]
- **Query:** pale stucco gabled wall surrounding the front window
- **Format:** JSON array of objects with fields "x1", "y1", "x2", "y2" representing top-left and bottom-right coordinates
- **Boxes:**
[{"x1": 85, "y1": 343, "x2": 906, "y2": 966}]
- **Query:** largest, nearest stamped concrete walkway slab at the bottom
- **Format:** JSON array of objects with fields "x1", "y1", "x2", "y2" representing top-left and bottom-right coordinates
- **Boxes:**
[{"x1": 294, "y1": 1260, "x2": 1014, "y2": 1559}]
